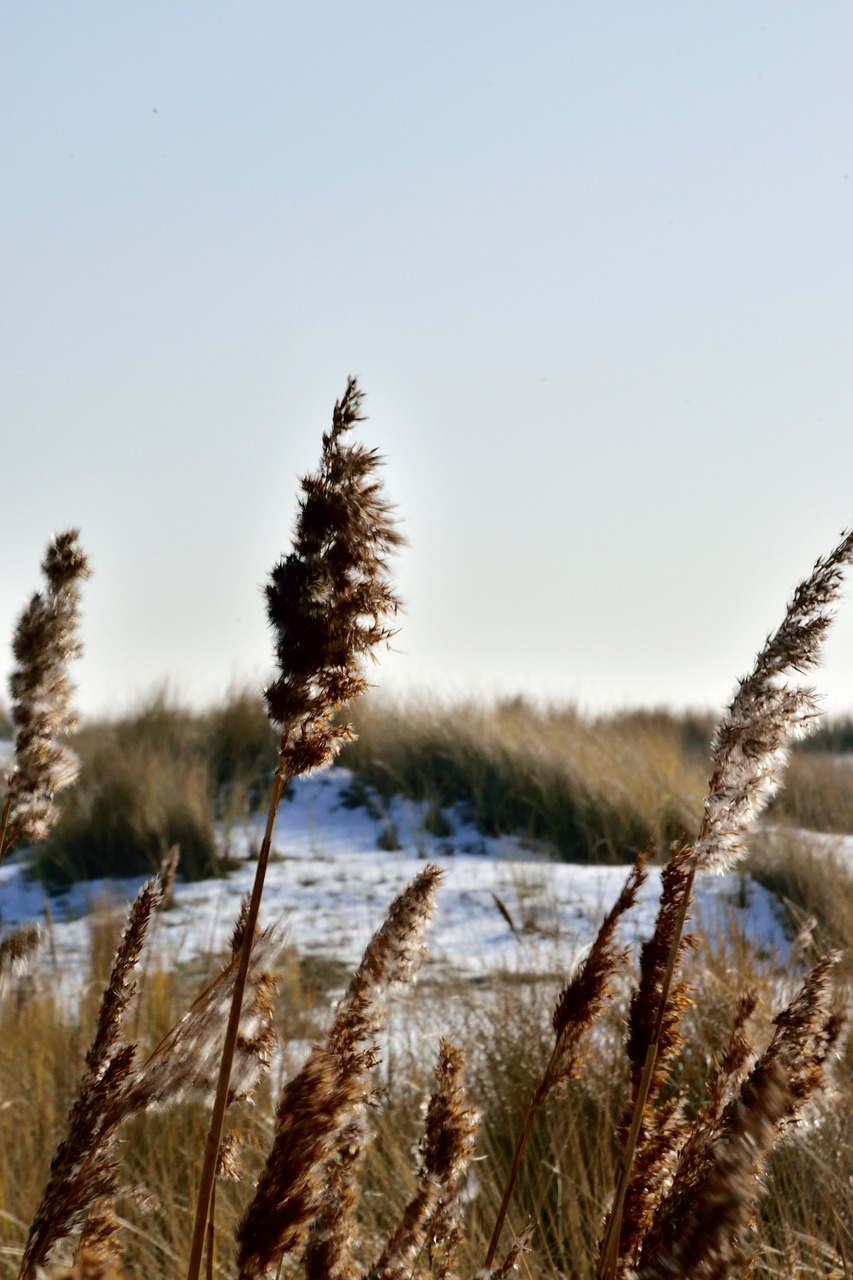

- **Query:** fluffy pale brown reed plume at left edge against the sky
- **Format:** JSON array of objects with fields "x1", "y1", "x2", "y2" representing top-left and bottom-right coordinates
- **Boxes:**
[{"x1": 0, "y1": 529, "x2": 90, "y2": 858}]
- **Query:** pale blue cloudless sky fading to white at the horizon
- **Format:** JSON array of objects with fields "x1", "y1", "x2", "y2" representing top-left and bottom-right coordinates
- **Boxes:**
[{"x1": 0, "y1": 0, "x2": 853, "y2": 714}]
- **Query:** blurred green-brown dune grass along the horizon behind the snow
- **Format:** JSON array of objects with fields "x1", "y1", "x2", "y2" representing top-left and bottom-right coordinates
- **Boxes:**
[{"x1": 3, "y1": 690, "x2": 853, "y2": 884}]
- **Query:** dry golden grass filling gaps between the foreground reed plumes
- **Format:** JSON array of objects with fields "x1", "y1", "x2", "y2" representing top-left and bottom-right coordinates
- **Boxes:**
[{"x1": 0, "y1": 922, "x2": 853, "y2": 1280}]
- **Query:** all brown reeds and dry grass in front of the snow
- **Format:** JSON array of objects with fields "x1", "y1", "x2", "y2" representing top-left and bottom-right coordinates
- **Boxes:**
[{"x1": 0, "y1": 381, "x2": 853, "y2": 1280}]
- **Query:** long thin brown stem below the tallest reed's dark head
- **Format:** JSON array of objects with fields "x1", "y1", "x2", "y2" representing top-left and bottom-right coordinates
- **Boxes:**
[{"x1": 187, "y1": 758, "x2": 291, "y2": 1280}]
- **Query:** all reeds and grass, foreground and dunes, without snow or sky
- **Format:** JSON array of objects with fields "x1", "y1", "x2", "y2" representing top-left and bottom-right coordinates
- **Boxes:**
[{"x1": 0, "y1": 381, "x2": 853, "y2": 1280}]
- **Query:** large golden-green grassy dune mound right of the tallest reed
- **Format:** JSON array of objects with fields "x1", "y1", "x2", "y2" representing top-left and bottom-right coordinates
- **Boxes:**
[{"x1": 342, "y1": 699, "x2": 708, "y2": 863}]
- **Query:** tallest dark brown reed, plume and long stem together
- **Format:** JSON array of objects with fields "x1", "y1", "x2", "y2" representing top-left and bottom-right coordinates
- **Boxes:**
[{"x1": 187, "y1": 378, "x2": 401, "y2": 1280}]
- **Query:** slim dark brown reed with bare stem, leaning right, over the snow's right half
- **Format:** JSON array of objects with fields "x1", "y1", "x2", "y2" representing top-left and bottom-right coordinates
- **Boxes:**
[{"x1": 485, "y1": 854, "x2": 647, "y2": 1272}]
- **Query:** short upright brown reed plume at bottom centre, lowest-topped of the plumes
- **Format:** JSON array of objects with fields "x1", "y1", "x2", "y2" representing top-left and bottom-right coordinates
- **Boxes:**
[{"x1": 368, "y1": 1039, "x2": 478, "y2": 1280}]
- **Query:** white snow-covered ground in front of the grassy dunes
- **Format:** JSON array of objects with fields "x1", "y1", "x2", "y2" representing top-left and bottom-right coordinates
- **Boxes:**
[{"x1": 0, "y1": 769, "x2": 786, "y2": 987}]
